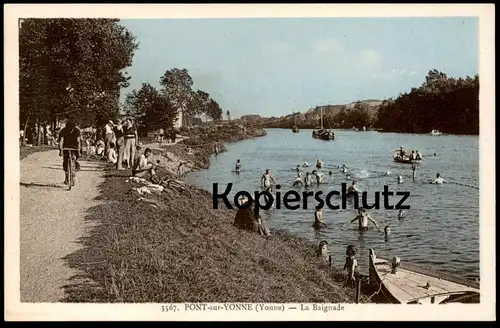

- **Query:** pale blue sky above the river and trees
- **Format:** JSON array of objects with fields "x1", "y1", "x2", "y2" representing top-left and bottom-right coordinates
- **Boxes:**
[{"x1": 121, "y1": 17, "x2": 479, "y2": 117}]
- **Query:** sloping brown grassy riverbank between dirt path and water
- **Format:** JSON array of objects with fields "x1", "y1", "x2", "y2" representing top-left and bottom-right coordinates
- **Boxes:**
[{"x1": 59, "y1": 126, "x2": 368, "y2": 303}]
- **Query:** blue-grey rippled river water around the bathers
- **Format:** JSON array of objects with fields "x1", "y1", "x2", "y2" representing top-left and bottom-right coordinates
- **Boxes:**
[{"x1": 187, "y1": 129, "x2": 479, "y2": 278}]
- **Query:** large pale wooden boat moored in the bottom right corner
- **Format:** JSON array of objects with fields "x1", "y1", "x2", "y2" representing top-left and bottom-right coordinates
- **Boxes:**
[{"x1": 369, "y1": 249, "x2": 480, "y2": 304}]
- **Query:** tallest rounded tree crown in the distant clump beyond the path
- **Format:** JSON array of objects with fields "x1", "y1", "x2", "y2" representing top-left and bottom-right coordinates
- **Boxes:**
[{"x1": 160, "y1": 68, "x2": 193, "y2": 127}]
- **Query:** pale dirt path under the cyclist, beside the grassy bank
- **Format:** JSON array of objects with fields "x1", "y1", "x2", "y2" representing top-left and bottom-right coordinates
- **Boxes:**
[{"x1": 20, "y1": 150, "x2": 105, "y2": 302}]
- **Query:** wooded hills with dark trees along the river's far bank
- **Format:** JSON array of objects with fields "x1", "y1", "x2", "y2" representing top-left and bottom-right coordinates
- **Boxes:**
[{"x1": 252, "y1": 69, "x2": 479, "y2": 135}]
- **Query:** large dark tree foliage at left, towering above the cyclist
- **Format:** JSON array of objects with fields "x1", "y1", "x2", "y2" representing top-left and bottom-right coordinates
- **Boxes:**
[{"x1": 19, "y1": 18, "x2": 138, "y2": 144}]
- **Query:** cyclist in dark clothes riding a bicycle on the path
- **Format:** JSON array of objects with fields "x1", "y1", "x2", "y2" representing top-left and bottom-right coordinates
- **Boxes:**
[{"x1": 58, "y1": 119, "x2": 82, "y2": 185}]
